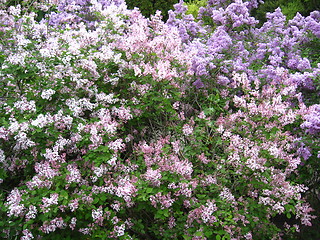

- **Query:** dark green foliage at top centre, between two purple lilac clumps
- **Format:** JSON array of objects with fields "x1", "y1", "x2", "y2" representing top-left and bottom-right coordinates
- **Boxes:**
[{"x1": 126, "y1": 0, "x2": 179, "y2": 21}]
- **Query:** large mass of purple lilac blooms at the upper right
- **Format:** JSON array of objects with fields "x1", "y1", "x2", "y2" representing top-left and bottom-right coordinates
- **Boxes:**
[{"x1": 168, "y1": 0, "x2": 319, "y2": 93}]
